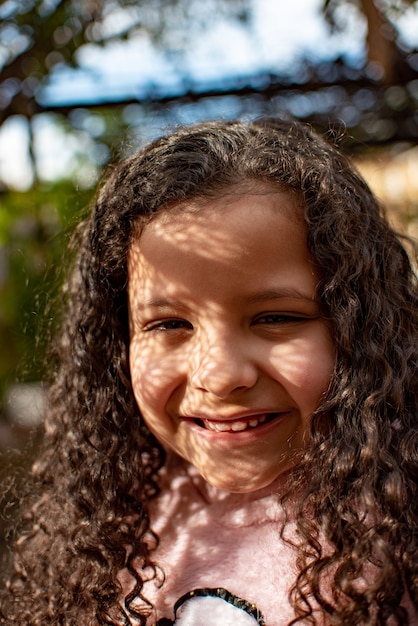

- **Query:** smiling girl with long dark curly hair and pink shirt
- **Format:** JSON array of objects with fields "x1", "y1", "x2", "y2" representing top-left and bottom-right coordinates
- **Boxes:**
[{"x1": 1, "y1": 120, "x2": 418, "y2": 626}]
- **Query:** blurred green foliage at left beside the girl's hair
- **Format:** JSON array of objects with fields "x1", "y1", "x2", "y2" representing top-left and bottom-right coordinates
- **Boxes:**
[{"x1": 0, "y1": 181, "x2": 91, "y2": 404}]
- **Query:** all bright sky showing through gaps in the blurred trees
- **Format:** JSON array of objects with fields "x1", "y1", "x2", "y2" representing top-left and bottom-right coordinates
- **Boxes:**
[{"x1": 0, "y1": 0, "x2": 418, "y2": 189}]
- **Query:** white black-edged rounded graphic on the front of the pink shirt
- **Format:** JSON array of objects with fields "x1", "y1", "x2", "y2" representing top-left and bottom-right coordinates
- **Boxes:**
[{"x1": 156, "y1": 587, "x2": 265, "y2": 626}]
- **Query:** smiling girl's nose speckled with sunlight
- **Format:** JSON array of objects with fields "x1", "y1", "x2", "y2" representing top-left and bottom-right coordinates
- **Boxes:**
[{"x1": 190, "y1": 338, "x2": 258, "y2": 398}]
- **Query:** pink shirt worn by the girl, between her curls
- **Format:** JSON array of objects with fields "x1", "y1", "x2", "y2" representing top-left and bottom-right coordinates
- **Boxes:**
[{"x1": 121, "y1": 457, "x2": 418, "y2": 626}]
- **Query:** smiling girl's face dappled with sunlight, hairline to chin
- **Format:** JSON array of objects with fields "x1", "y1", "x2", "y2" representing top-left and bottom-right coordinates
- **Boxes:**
[{"x1": 128, "y1": 188, "x2": 334, "y2": 492}]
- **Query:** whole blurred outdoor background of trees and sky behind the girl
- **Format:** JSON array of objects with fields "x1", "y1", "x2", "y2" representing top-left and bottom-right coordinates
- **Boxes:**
[{"x1": 0, "y1": 0, "x2": 418, "y2": 576}]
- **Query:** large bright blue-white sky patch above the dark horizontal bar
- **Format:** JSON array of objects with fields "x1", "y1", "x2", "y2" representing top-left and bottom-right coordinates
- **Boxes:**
[{"x1": 40, "y1": 0, "x2": 365, "y2": 103}]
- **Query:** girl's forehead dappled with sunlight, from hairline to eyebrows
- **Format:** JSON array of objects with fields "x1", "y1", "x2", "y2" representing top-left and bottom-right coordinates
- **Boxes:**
[{"x1": 128, "y1": 188, "x2": 312, "y2": 300}]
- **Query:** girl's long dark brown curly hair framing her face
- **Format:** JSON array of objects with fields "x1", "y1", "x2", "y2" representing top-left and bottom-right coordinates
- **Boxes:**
[{"x1": 0, "y1": 119, "x2": 418, "y2": 626}]
